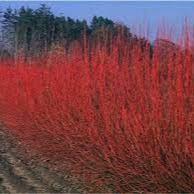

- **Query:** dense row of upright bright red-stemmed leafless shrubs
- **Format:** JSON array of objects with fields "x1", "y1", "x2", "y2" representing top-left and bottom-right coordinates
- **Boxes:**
[{"x1": 0, "y1": 26, "x2": 194, "y2": 192}]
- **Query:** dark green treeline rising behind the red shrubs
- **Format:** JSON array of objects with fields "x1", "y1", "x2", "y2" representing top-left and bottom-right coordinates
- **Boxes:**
[{"x1": 0, "y1": 4, "x2": 152, "y2": 57}]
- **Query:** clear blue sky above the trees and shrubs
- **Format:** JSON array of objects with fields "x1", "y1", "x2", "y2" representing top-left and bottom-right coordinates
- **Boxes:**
[{"x1": 0, "y1": 1, "x2": 194, "y2": 38}]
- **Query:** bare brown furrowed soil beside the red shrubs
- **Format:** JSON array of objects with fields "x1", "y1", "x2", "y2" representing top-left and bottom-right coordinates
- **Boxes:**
[{"x1": 0, "y1": 125, "x2": 84, "y2": 193}]
